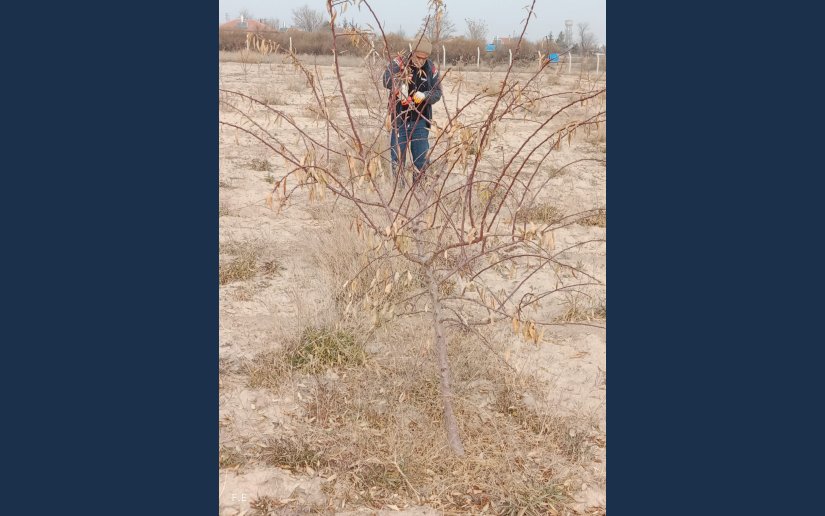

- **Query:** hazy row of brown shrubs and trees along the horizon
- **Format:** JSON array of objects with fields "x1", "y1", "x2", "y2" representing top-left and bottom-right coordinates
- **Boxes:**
[{"x1": 219, "y1": 5, "x2": 606, "y2": 63}]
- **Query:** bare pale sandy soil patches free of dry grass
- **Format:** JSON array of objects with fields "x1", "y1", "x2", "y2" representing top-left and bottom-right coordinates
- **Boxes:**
[{"x1": 219, "y1": 54, "x2": 607, "y2": 515}]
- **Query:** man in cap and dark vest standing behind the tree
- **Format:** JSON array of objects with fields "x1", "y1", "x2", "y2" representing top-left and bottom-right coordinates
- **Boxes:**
[{"x1": 384, "y1": 38, "x2": 441, "y2": 184}]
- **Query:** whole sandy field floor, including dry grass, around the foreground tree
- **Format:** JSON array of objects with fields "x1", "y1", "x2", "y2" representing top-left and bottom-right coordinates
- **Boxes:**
[{"x1": 219, "y1": 53, "x2": 607, "y2": 515}]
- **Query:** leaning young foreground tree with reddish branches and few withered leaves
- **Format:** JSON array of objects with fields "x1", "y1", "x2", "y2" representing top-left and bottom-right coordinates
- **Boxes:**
[{"x1": 220, "y1": 0, "x2": 606, "y2": 456}]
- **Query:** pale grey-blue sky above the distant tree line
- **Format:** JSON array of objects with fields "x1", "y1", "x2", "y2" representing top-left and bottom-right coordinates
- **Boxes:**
[{"x1": 218, "y1": 0, "x2": 607, "y2": 45}]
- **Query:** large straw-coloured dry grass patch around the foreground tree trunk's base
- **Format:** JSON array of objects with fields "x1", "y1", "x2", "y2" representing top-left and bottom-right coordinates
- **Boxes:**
[{"x1": 274, "y1": 324, "x2": 591, "y2": 514}]
